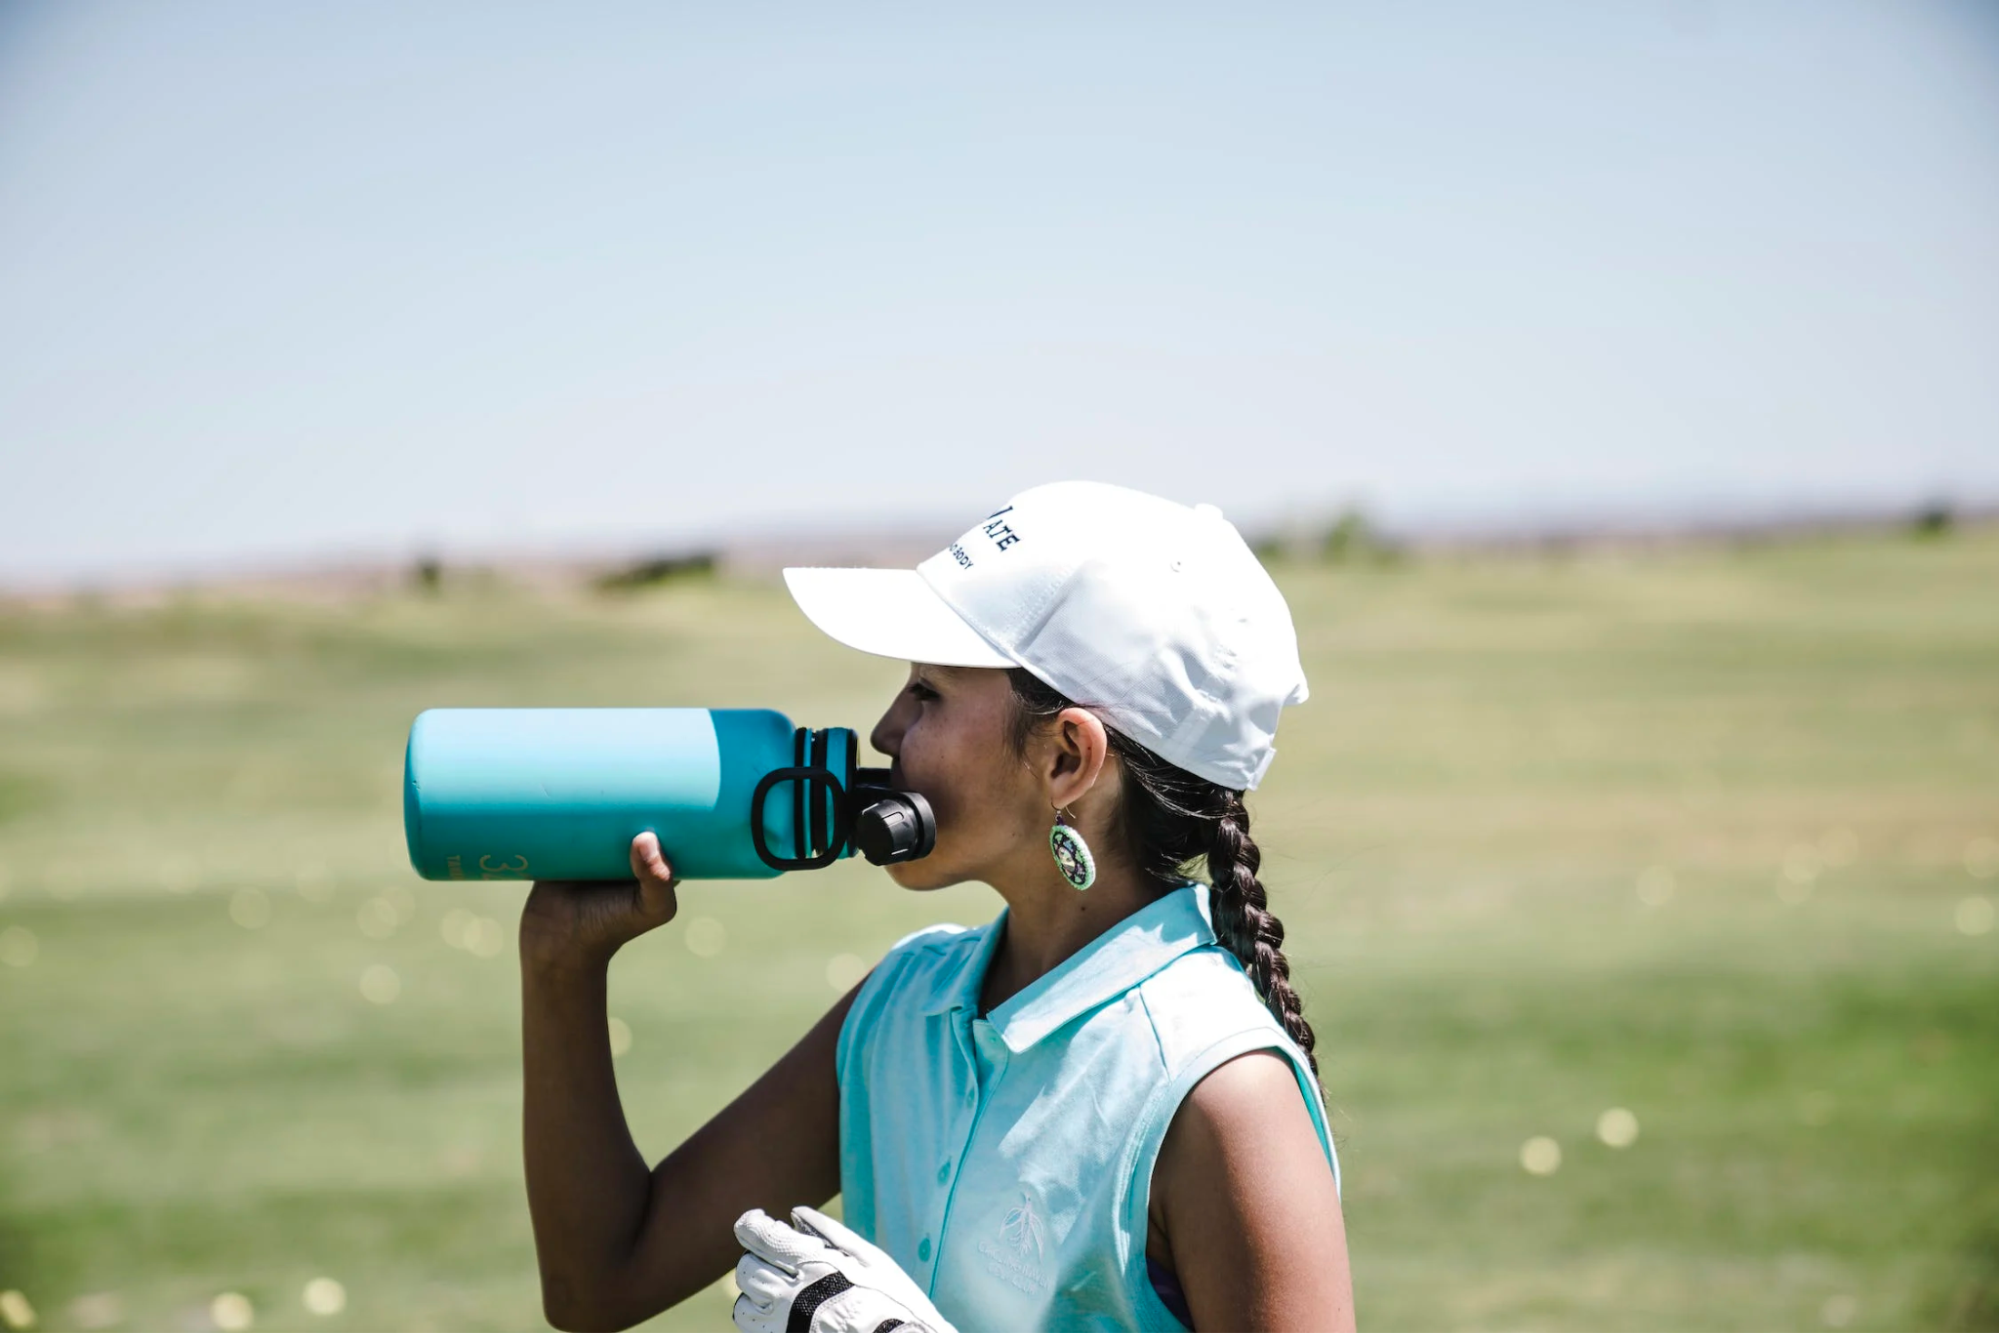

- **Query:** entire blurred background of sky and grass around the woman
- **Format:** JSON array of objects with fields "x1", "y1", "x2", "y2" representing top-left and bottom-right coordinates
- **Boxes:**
[{"x1": 0, "y1": 0, "x2": 1999, "y2": 1330}]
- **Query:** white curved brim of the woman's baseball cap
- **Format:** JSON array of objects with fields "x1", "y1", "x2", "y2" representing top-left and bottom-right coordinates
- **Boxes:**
[{"x1": 784, "y1": 568, "x2": 1013, "y2": 668}]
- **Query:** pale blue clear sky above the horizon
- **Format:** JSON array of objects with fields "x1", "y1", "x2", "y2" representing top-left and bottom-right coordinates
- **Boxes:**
[{"x1": 0, "y1": 0, "x2": 1999, "y2": 582}]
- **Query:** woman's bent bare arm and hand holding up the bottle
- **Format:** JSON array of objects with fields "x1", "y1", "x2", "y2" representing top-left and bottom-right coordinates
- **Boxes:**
[{"x1": 520, "y1": 834, "x2": 854, "y2": 1330}]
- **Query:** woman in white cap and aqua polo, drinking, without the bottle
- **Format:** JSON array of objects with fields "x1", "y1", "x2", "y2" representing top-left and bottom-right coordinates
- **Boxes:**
[{"x1": 522, "y1": 482, "x2": 1353, "y2": 1330}]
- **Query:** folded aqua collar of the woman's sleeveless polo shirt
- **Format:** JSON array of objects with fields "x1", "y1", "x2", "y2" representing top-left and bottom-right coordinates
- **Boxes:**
[{"x1": 930, "y1": 884, "x2": 1215, "y2": 1054}]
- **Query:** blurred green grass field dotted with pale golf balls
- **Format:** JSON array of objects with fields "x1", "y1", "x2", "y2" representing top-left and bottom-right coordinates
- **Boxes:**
[{"x1": 0, "y1": 530, "x2": 1999, "y2": 1330}]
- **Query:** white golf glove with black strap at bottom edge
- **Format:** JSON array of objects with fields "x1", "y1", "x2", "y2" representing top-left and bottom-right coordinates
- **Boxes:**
[{"x1": 730, "y1": 1204, "x2": 958, "y2": 1334}]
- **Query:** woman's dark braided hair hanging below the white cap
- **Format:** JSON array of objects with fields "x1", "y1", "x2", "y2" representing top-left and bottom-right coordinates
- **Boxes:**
[{"x1": 1007, "y1": 668, "x2": 1319, "y2": 1074}]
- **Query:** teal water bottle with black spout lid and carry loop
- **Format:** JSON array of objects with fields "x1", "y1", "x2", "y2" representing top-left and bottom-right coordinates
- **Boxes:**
[{"x1": 402, "y1": 708, "x2": 938, "y2": 880}]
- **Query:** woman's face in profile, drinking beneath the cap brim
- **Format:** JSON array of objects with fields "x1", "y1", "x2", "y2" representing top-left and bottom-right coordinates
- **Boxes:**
[{"x1": 868, "y1": 664, "x2": 1053, "y2": 890}]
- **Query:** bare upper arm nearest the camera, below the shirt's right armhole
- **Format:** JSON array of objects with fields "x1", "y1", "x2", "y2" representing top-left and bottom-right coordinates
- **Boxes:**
[{"x1": 1145, "y1": 1052, "x2": 1353, "y2": 1330}]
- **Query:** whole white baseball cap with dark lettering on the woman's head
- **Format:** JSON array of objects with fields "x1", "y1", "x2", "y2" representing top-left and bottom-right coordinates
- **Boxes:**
[{"x1": 784, "y1": 482, "x2": 1309, "y2": 790}]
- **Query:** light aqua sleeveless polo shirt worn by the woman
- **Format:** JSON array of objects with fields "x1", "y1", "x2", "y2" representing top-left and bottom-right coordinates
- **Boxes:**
[{"x1": 838, "y1": 886, "x2": 1339, "y2": 1330}]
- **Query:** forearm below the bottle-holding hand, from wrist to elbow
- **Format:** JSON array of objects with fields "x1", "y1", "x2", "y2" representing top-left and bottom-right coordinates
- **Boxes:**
[{"x1": 522, "y1": 962, "x2": 652, "y2": 1328}]
